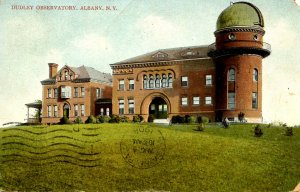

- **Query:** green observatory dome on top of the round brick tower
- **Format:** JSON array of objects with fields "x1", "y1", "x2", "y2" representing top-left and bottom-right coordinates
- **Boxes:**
[{"x1": 217, "y1": 2, "x2": 264, "y2": 30}]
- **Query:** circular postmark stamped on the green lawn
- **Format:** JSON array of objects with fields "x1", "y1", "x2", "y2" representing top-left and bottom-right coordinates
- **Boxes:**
[{"x1": 120, "y1": 125, "x2": 166, "y2": 169}]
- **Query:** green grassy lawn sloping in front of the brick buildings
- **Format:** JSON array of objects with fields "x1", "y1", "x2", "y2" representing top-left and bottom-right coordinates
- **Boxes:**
[{"x1": 0, "y1": 123, "x2": 300, "y2": 192}]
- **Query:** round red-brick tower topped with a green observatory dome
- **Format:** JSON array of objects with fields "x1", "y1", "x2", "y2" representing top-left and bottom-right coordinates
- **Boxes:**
[{"x1": 209, "y1": 2, "x2": 271, "y2": 122}]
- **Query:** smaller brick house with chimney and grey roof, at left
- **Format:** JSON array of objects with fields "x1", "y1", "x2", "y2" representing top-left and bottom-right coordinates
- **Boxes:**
[{"x1": 41, "y1": 63, "x2": 112, "y2": 123}]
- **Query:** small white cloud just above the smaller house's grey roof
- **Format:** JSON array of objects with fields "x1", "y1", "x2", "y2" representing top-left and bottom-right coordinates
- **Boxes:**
[{"x1": 72, "y1": 33, "x2": 112, "y2": 57}]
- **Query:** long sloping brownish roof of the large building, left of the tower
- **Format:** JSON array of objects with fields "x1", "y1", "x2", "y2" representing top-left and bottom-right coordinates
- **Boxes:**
[{"x1": 111, "y1": 45, "x2": 208, "y2": 65}]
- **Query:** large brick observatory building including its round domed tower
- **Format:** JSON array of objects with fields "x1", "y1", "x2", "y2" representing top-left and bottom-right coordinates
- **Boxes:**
[{"x1": 111, "y1": 2, "x2": 270, "y2": 122}]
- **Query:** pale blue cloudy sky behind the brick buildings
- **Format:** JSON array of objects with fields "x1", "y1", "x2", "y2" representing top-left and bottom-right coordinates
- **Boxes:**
[{"x1": 0, "y1": 0, "x2": 300, "y2": 125}]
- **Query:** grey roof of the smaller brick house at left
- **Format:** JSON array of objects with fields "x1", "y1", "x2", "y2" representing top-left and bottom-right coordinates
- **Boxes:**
[{"x1": 41, "y1": 65, "x2": 112, "y2": 84}]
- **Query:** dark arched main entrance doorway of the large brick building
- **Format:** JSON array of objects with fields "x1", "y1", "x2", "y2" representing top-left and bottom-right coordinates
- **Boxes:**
[{"x1": 149, "y1": 97, "x2": 168, "y2": 119}]
